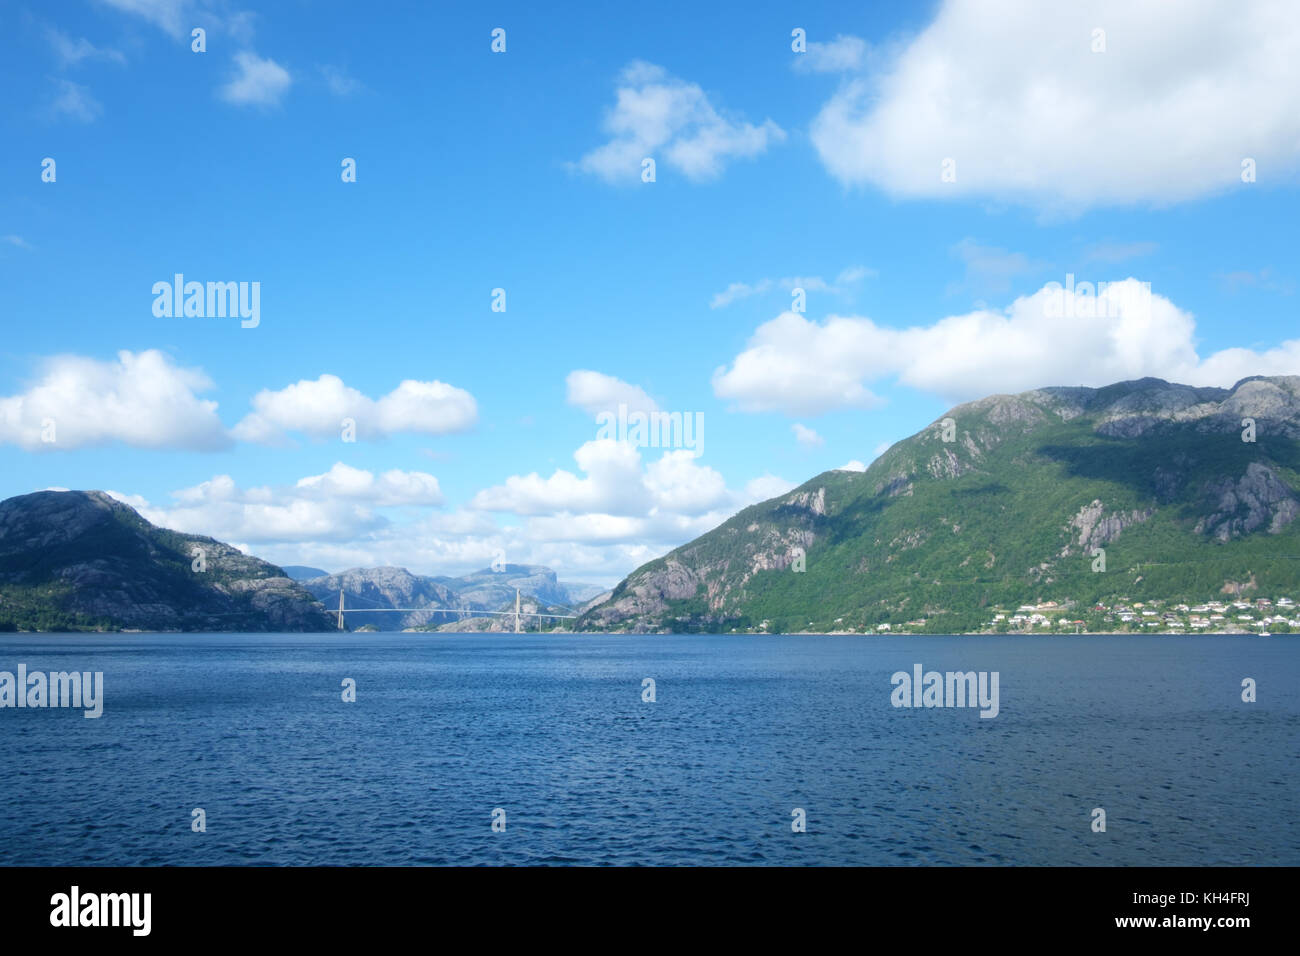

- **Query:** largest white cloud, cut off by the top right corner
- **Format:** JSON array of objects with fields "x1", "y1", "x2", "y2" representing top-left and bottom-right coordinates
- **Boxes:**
[{"x1": 811, "y1": 0, "x2": 1300, "y2": 208}]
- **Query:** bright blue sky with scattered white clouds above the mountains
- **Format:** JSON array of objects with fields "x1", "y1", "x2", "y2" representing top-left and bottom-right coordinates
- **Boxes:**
[{"x1": 0, "y1": 0, "x2": 1300, "y2": 583}]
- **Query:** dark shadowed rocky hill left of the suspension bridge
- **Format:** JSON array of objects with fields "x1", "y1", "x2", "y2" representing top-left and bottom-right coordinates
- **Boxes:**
[{"x1": 0, "y1": 492, "x2": 332, "y2": 631}]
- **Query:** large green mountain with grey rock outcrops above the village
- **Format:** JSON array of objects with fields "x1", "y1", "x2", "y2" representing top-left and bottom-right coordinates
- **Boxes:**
[{"x1": 577, "y1": 376, "x2": 1300, "y2": 632}]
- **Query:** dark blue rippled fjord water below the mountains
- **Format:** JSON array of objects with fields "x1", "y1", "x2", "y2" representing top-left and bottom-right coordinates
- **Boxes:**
[{"x1": 0, "y1": 633, "x2": 1300, "y2": 865}]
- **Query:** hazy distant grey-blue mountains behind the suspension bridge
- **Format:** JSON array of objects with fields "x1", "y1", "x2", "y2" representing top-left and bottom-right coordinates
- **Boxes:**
[{"x1": 303, "y1": 564, "x2": 601, "y2": 631}]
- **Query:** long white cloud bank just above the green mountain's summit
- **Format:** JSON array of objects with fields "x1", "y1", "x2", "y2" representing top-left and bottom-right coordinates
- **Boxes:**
[{"x1": 714, "y1": 278, "x2": 1300, "y2": 415}]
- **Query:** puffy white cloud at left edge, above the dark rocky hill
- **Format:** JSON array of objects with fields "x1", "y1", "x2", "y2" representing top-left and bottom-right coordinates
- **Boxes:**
[{"x1": 0, "y1": 349, "x2": 229, "y2": 451}]
